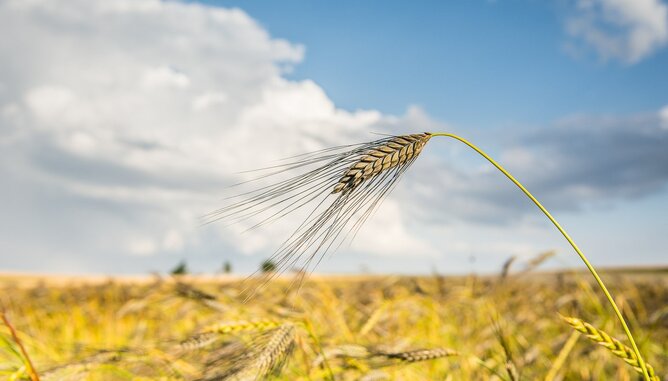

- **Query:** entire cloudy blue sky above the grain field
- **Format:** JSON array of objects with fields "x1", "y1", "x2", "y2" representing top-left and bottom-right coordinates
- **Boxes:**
[{"x1": 0, "y1": 0, "x2": 668, "y2": 274}]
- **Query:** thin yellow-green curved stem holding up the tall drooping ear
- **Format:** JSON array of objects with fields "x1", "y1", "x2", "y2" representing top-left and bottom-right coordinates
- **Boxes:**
[{"x1": 431, "y1": 132, "x2": 651, "y2": 381}]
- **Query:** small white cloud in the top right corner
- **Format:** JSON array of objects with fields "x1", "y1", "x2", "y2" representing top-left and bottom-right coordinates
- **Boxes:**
[{"x1": 566, "y1": 0, "x2": 668, "y2": 64}]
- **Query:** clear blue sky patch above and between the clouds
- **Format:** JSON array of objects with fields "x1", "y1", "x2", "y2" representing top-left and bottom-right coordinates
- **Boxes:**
[{"x1": 211, "y1": 1, "x2": 668, "y2": 124}]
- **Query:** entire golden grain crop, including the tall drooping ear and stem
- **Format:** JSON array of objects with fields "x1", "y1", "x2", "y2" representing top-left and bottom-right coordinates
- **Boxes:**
[{"x1": 0, "y1": 133, "x2": 668, "y2": 381}]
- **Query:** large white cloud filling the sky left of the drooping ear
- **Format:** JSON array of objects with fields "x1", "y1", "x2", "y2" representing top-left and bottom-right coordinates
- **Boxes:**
[{"x1": 0, "y1": 0, "x2": 438, "y2": 271}]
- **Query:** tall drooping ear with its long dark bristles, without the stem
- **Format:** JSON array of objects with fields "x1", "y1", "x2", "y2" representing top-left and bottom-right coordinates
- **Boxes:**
[{"x1": 205, "y1": 132, "x2": 432, "y2": 284}]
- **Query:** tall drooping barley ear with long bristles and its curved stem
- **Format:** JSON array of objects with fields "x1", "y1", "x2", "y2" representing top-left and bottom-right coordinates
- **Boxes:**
[{"x1": 209, "y1": 132, "x2": 651, "y2": 381}]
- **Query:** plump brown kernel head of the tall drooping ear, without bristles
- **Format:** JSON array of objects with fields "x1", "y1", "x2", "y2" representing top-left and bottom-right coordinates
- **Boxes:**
[{"x1": 332, "y1": 132, "x2": 431, "y2": 194}]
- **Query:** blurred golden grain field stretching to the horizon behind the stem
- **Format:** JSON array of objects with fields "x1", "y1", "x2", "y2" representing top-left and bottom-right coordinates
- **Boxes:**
[{"x1": 0, "y1": 272, "x2": 668, "y2": 381}]
